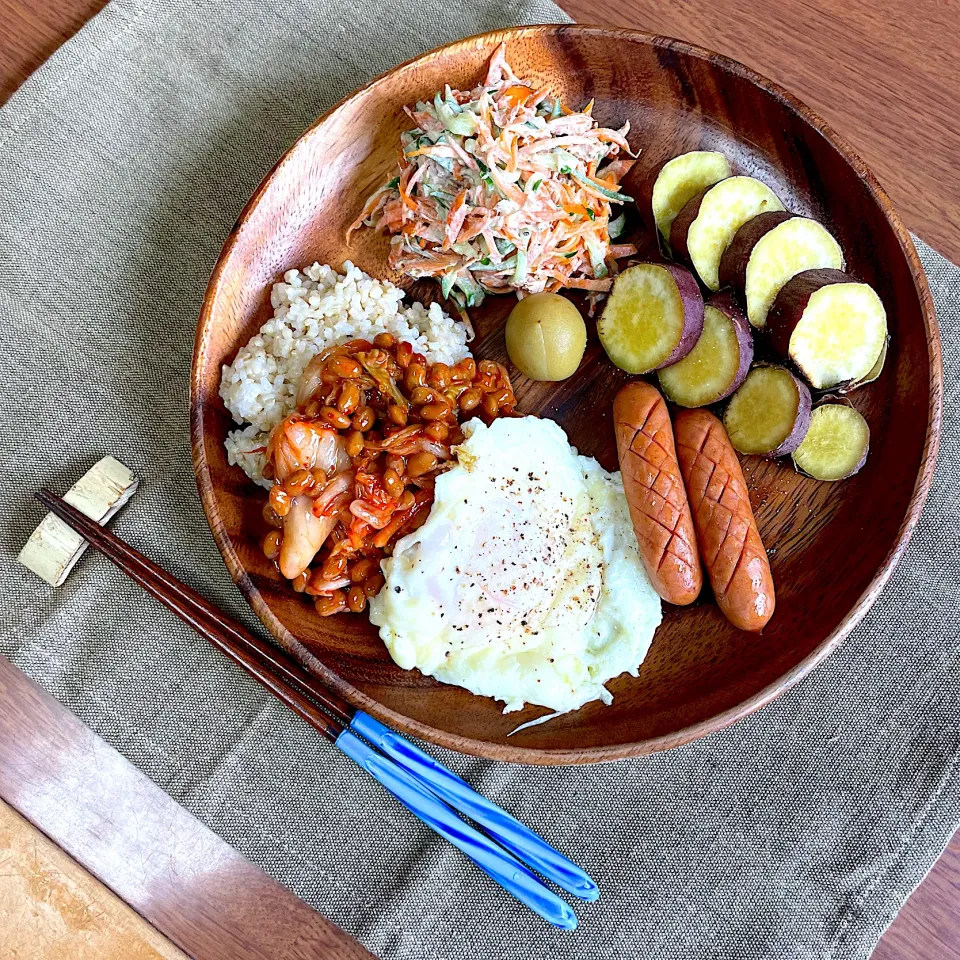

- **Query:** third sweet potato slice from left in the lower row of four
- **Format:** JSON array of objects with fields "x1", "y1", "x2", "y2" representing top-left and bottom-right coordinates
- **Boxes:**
[{"x1": 723, "y1": 365, "x2": 810, "y2": 457}]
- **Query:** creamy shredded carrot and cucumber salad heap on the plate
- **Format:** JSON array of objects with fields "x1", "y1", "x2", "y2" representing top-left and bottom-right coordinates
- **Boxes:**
[{"x1": 348, "y1": 46, "x2": 635, "y2": 316}]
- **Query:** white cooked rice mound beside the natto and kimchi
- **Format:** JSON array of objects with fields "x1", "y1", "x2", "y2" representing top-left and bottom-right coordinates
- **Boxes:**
[{"x1": 220, "y1": 260, "x2": 468, "y2": 487}]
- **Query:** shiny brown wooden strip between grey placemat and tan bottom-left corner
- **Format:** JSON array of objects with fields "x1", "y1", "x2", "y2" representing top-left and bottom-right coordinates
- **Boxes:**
[{"x1": 0, "y1": 657, "x2": 371, "y2": 960}]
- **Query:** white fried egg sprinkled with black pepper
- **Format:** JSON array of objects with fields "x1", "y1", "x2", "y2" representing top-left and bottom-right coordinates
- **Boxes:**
[{"x1": 370, "y1": 417, "x2": 661, "y2": 713}]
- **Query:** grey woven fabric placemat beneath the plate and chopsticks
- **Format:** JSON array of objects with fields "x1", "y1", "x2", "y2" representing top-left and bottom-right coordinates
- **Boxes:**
[{"x1": 0, "y1": 0, "x2": 960, "y2": 960}]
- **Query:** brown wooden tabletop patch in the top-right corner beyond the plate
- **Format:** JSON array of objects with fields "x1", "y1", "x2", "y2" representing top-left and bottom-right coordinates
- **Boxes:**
[{"x1": 560, "y1": 0, "x2": 960, "y2": 262}]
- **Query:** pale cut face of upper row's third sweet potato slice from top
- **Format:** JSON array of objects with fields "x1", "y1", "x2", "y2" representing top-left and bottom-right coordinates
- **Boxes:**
[{"x1": 743, "y1": 217, "x2": 840, "y2": 328}]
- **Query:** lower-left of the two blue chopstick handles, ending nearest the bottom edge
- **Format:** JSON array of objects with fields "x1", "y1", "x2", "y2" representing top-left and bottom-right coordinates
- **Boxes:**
[{"x1": 337, "y1": 728, "x2": 577, "y2": 930}]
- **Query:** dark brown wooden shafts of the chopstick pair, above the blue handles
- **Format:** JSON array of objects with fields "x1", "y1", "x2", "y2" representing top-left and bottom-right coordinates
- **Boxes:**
[{"x1": 36, "y1": 489, "x2": 355, "y2": 741}]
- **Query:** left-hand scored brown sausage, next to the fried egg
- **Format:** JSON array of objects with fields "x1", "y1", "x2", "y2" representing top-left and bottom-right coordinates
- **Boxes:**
[{"x1": 613, "y1": 380, "x2": 703, "y2": 606}]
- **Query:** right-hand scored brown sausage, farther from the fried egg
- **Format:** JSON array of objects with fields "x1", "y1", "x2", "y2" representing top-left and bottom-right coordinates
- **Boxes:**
[{"x1": 674, "y1": 410, "x2": 776, "y2": 631}]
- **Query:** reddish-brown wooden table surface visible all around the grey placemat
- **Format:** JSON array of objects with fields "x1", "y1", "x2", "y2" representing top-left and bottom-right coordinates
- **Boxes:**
[{"x1": 0, "y1": 0, "x2": 960, "y2": 960}]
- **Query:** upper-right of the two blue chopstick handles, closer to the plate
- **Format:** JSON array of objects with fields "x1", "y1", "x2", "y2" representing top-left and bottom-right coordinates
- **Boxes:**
[{"x1": 350, "y1": 710, "x2": 600, "y2": 901}]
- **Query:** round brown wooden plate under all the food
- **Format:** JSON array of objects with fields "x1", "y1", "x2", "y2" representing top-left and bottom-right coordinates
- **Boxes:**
[{"x1": 192, "y1": 26, "x2": 942, "y2": 764}]
